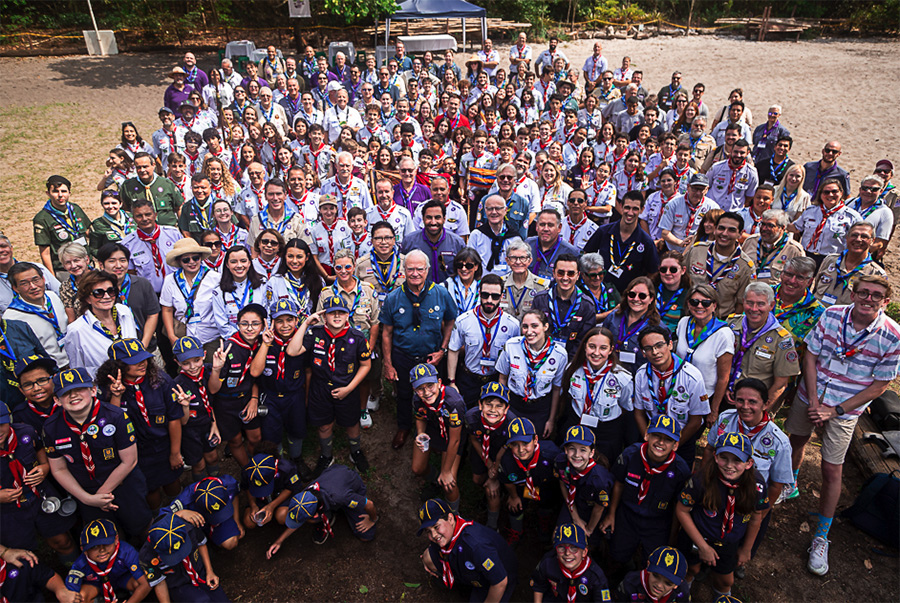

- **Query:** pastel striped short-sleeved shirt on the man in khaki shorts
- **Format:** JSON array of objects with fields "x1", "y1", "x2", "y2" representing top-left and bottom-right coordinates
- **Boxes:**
[{"x1": 799, "y1": 305, "x2": 900, "y2": 419}]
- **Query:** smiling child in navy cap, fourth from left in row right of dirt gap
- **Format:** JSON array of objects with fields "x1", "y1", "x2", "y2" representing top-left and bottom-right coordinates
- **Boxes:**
[{"x1": 554, "y1": 425, "x2": 614, "y2": 546}]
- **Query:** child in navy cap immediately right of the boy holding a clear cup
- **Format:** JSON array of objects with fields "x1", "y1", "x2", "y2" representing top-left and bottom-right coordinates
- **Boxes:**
[{"x1": 466, "y1": 383, "x2": 516, "y2": 530}]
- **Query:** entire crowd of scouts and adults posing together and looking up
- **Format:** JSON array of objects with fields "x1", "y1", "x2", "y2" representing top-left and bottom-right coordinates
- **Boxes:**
[{"x1": 0, "y1": 34, "x2": 900, "y2": 603}]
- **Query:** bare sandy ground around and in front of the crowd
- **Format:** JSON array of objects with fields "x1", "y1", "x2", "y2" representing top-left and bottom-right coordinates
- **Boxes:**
[{"x1": 0, "y1": 36, "x2": 900, "y2": 601}]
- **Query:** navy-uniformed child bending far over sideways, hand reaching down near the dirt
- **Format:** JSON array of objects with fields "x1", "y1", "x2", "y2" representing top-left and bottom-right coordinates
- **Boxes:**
[{"x1": 266, "y1": 465, "x2": 378, "y2": 559}]
